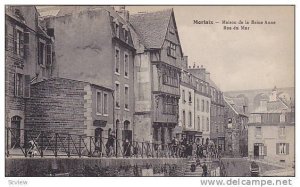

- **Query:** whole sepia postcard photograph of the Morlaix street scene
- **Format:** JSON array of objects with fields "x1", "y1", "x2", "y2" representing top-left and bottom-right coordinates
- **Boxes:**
[{"x1": 2, "y1": 4, "x2": 296, "y2": 180}]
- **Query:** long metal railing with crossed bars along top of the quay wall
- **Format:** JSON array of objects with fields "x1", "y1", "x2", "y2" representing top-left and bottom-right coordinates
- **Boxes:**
[{"x1": 5, "y1": 127, "x2": 180, "y2": 158}]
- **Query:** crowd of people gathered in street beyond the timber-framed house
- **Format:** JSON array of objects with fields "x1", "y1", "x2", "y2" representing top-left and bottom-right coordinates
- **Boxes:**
[{"x1": 170, "y1": 137, "x2": 222, "y2": 159}]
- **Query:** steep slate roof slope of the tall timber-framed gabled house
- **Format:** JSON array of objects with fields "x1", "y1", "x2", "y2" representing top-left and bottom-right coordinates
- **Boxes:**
[{"x1": 129, "y1": 9, "x2": 173, "y2": 49}]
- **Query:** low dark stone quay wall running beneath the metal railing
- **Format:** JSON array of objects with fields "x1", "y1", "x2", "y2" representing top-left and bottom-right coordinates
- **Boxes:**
[{"x1": 5, "y1": 158, "x2": 186, "y2": 177}]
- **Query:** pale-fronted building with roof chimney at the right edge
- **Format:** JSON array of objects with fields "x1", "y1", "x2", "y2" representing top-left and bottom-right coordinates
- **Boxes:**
[{"x1": 248, "y1": 87, "x2": 295, "y2": 166}]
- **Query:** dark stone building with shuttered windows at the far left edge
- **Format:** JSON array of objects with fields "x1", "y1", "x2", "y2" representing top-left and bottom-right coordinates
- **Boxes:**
[{"x1": 5, "y1": 6, "x2": 55, "y2": 146}]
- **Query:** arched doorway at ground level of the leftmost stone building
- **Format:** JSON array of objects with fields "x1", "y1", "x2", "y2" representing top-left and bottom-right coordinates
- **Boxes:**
[{"x1": 10, "y1": 116, "x2": 22, "y2": 147}]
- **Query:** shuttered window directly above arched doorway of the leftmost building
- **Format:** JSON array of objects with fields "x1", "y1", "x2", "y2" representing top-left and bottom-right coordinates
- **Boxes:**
[{"x1": 14, "y1": 73, "x2": 31, "y2": 98}]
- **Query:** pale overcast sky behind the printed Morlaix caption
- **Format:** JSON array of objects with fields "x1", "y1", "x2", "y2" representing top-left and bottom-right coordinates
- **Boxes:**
[{"x1": 126, "y1": 6, "x2": 294, "y2": 91}]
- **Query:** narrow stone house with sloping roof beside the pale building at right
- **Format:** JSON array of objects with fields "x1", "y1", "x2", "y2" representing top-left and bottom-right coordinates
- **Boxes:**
[{"x1": 224, "y1": 97, "x2": 248, "y2": 157}]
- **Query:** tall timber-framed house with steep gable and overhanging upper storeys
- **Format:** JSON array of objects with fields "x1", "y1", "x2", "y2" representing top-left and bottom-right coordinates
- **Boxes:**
[{"x1": 129, "y1": 9, "x2": 184, "y2": 144}]
